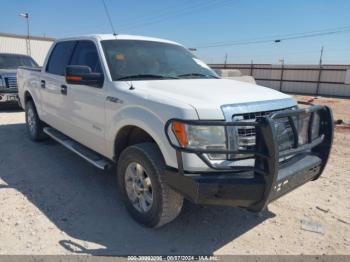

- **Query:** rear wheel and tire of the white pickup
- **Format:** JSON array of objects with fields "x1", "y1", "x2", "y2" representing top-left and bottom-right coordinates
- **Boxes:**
[{"x1": 25, "y1": 100, "x2": 47, "y2": 141}]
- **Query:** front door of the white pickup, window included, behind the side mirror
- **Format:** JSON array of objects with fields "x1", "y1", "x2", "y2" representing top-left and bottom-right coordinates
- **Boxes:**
[{"x1": 65, "y1": 40, "x2": 106, "y2": 154}]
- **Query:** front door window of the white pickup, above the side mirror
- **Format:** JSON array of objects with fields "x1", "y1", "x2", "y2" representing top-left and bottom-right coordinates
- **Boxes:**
[{"x1": 70, "y1": 41, "x2": 102, "y2": 73}]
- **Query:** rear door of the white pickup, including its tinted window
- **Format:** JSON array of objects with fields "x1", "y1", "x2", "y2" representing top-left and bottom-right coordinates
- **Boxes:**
[{"x1": 40, "y1": 41, "x2": 77, "y2": 134}]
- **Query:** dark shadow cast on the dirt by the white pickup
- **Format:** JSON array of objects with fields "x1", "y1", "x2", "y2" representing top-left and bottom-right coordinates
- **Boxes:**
[{"x1": 0, "y1": 124, "x2": 274, "y2": 256}]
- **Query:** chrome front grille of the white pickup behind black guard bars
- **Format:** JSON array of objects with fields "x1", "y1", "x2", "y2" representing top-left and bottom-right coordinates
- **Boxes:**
[{"x1": 229, "y1": 108, "x2": 293, "y2": 159}]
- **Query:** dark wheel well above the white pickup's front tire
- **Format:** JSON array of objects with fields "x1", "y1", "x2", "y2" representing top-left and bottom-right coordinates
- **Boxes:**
[{"x1": 114, "y1": 126, "x2": 155, "y2": 161}]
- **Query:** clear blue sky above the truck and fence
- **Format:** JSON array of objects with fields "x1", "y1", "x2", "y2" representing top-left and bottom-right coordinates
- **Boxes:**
[{"x1": 0, "y1": 0, "x2": 350, "y2": 64}]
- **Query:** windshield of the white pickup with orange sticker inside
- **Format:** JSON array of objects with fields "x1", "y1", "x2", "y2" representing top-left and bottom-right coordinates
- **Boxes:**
[{"x1": 101, "y1": 40, "x2": 218, "y2": 81}]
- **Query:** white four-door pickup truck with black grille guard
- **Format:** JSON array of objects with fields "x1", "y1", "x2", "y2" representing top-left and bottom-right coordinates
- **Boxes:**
[{"x1": 17, "y1": 35, "x2": 333, "y2": 227}]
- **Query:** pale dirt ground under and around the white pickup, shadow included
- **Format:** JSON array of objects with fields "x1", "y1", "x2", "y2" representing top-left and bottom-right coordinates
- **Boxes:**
[{"x1": 0, "y1": 97, "x2": 350, "y2": 255}]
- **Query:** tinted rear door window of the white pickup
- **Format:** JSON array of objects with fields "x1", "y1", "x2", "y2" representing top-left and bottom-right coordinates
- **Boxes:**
[{"x1": 46, "y1": 41, "x2": 77, "y2": 76}]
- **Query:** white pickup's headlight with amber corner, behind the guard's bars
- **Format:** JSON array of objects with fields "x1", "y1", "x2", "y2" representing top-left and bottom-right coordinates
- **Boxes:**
[{"x1": 172, "y1": 121, "x2": 227, "y2": 160}]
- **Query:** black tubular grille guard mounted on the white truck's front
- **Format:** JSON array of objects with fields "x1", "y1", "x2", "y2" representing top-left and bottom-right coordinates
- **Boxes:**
[{"x1": 165, "y1": 105, "x2": 333, "y2": 210}]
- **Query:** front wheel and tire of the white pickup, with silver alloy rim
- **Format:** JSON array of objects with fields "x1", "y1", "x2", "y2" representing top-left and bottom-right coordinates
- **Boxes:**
[{"x1": 118, "y1": 143, "x2": 183, "y2": 227}]
